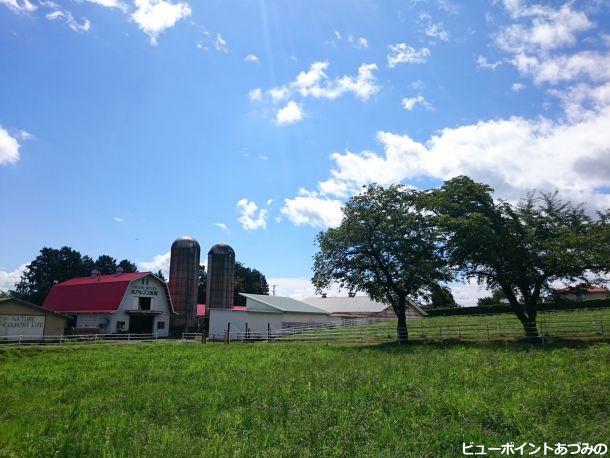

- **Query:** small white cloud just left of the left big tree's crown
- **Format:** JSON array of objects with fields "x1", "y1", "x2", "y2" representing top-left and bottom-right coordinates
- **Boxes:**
[{"x1": 281, "y1": 193, "x2": 343, "y2": 228}]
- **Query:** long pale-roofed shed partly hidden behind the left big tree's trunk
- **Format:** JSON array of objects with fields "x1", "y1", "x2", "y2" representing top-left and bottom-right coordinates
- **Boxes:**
[{"x1": 303, "y1": 295, "x2": 427, "y2": 320}]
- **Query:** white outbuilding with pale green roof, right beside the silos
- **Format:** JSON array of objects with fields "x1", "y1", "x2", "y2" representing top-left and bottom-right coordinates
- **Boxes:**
[{"x1": 209, "y1": 293, "x2": 329, "y2": 339}]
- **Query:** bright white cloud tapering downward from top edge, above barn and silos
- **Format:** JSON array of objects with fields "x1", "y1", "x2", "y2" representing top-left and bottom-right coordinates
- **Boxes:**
[{"x1": 131, "y1": 0, "x2": 191, "y2": 45}]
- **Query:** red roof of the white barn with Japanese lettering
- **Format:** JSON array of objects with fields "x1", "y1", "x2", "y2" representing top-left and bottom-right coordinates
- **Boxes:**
[{"x1": 42, "y1": 272, "x2": 151, "y2": 313}]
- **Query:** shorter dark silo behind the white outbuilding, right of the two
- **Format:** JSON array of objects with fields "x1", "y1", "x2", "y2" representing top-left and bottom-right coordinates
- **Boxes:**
[{"x1": 206, "y1": 243, "x2": 235, "y2": 309}]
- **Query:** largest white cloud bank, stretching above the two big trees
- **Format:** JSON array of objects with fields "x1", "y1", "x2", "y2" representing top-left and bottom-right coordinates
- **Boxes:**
[{"x1": 312, "y1": 110, "x2": 610, "y2": 208}]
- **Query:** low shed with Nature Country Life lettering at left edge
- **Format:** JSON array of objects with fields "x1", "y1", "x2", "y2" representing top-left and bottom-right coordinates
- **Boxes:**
[{"x1": 0, "y1": 297, "x2": 66, "y2": 340}]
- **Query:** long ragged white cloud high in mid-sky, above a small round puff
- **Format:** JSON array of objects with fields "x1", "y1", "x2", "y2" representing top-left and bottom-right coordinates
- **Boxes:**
[{"x1": 250, "y1": 61, "x2": 380, "y2": 108}]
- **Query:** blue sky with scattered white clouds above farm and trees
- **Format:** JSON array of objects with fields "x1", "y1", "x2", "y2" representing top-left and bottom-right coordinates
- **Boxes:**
[{"x1": 0, "y1": 0, "x2": 610, "y2": 303}]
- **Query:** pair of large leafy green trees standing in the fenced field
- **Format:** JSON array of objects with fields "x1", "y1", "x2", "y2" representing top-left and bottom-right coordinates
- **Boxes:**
[{"x1": 312, "y1": 176, "x2": 610, "y2": 342}]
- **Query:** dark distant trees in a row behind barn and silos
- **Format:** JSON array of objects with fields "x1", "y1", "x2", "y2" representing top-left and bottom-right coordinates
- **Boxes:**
[{"x1": 8, "y1": 246, "x2": 269, "y2": 305}]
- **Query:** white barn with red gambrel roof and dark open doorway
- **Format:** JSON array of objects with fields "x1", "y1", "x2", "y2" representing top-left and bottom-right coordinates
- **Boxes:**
[{"x1": 43, "y1": 272, "x2": 173, "y2": 337}]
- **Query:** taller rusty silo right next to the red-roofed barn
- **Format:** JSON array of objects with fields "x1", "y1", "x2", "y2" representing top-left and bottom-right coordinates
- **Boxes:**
[{"x1": 169, "y1": 237, "x2": 201, "y2": 332}]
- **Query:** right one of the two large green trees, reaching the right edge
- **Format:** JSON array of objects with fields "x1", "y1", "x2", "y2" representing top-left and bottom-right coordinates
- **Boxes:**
[{"x1": 425, "y1": 176, "x2": 610, "y2": 337}]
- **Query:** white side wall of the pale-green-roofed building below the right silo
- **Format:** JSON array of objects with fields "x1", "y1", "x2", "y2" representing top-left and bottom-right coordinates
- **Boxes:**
[{"x1": 208, "y1": 309, "x2": 282, "y2": 339}]
